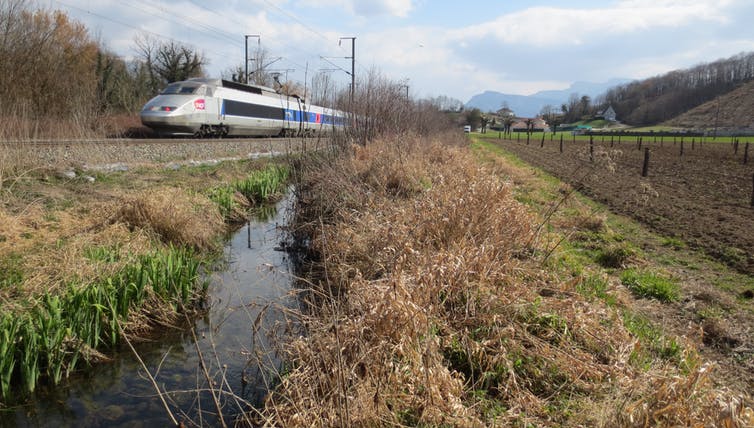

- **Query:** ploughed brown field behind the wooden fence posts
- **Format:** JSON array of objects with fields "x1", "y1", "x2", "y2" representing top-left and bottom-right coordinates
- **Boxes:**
[{"x1": 484, "y1": 133, "x2": 754, "y2": 274}]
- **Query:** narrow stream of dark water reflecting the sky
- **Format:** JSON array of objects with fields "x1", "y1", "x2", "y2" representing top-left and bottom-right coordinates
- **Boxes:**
[{"x1": 6, "y1": 192, "x2": 297, "y2": 428}]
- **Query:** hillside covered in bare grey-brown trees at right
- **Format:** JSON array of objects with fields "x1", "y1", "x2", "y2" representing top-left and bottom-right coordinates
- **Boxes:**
[{"x1": 598, "y1": 52, "x2": 754, "y2": 128}]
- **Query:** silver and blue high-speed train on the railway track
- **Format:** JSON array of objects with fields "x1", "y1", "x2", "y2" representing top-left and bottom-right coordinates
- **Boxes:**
[{"x1": 140, "y1": 78, "x2": 347, "y2": 138}]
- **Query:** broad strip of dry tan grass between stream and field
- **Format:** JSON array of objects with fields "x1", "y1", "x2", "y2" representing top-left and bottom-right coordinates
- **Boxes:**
[{"x1": 266, "y1": 137, "x2": 752, "y2": 426}]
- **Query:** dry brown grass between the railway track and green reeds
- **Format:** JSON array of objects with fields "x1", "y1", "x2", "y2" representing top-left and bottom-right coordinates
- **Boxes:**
[{"x1": 0, "y1": 158, "x2": 268, "y2": 324}]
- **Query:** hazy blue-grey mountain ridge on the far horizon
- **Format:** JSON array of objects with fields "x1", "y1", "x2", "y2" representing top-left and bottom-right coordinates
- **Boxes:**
[{"x1": 465, "y1": 79, "x2": 629, "y2": 117}]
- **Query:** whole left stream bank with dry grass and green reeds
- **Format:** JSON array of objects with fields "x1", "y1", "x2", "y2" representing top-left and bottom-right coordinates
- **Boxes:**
[{"x1": 0, "y1": 155, "x2": 287, "y2": 403}]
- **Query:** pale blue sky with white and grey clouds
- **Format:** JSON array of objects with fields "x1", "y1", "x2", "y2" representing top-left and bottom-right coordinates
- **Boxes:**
[{"x1": 47, "y1": 0, "x2": 754, "y2": 102}]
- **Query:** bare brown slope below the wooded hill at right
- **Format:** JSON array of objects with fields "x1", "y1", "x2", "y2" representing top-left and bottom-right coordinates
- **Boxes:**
[{"x1": 665, "y1": 81, "x2": 754, "y2": 132}]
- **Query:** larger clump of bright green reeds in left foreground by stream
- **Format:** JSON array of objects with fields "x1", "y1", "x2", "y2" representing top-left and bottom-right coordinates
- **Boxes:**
[{"x1": 0, "y1": 247, "x2": 207, "y2": 399}]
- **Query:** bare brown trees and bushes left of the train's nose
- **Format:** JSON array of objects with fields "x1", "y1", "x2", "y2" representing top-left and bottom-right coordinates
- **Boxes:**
[{"x1": 0, "y1": 0, "x2": 206, "y2": 136}]
